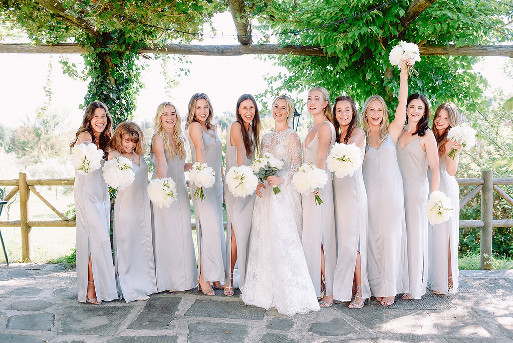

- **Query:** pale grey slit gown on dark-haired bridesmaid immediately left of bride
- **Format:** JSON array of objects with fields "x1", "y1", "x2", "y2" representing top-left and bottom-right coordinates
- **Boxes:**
[{"x1": 224, "y1": 125, "x2": 256, "y2": 287}]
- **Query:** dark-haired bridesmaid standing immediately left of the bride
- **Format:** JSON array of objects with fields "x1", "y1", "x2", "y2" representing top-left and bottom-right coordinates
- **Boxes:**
[{"x1": 224, "y1": 94, "x2": 260, "y2": 296}]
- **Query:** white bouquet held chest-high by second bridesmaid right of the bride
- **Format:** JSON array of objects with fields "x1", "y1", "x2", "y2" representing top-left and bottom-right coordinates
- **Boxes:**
[{"x1": 326, "y1": 143, "x2": 363, "y2": 178}]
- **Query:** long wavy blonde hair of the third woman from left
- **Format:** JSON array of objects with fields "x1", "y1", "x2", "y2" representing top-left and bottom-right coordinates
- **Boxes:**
[{"x1": 154, "y1": 102, "x2": 185, "y2": 159}]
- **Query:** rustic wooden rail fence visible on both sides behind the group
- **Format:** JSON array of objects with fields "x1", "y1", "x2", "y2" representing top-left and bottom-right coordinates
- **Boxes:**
[{"x1": 0, "y1": 170, "x2": 513, "y2": 269}]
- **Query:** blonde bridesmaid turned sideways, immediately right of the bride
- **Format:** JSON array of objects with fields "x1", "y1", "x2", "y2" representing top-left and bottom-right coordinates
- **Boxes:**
[{"x1": 302, "y1": 87, "x2": 337, "y2": 307}]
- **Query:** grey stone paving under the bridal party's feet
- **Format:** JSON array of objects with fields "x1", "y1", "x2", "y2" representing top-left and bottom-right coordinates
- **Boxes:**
[{"x1": 0, "y1": 264, "x2": 513, "y2": 343}]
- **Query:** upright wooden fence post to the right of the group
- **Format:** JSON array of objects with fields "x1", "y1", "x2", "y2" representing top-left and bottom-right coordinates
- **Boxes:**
[{"x1": 480, "y1": 170, "x2": 493, "y2": 269}]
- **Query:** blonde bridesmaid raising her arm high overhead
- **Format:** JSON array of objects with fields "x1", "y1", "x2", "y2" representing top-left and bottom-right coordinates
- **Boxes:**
[{"x1": 362, "y1": 64, "x2": 408, "y2": 306}]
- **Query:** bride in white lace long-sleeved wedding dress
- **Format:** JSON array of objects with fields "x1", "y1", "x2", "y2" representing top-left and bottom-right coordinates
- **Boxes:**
[{"x1": 241, "y1": 95, "x2": 319, "y2": 316}]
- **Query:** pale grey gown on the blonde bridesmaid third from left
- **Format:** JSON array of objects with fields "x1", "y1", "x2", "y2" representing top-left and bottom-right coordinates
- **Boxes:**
[{"x1": 151, "y1": 151, "x2": 198, "y2": 292}]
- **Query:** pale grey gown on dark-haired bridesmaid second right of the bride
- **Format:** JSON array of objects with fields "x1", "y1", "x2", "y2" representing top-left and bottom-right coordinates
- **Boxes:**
[{"x1": 333, "y1": 140, "x2": 370, "y2": 301}]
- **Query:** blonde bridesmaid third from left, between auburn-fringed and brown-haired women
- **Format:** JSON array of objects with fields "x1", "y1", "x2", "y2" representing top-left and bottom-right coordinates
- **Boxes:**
[{"x1": 151, "y1": 102, "x2": 198, "y2": 292}]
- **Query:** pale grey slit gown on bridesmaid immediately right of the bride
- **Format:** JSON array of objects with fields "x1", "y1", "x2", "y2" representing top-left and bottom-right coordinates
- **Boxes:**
[{"x1": 301, "y1": 121, "x2": 337, "y2": 297}]
